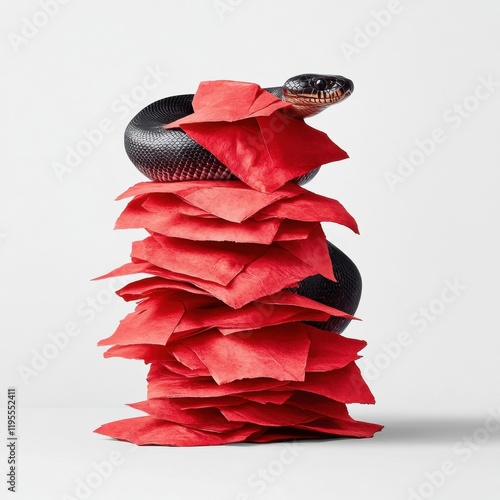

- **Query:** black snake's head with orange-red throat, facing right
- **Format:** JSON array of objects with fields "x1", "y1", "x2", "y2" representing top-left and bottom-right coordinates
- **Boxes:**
[{"x1": 283, "y1": 73, "x2": 354, "y2": 118}]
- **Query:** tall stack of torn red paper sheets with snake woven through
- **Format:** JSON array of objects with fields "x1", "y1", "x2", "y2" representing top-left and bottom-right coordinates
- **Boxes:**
[{"x1": 96, "y1": 82, "x2": 381, "y2": 446}]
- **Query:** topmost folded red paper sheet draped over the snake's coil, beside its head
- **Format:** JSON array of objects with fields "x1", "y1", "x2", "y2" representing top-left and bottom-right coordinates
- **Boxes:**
[{"x1": 165, "y1": 81, "x2": 348, "y2": 192}]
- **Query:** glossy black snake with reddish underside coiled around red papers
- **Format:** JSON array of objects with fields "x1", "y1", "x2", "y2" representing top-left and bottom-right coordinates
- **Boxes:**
[{"x1": 124, "y1": 73, "x2": 362, "y2": 333}]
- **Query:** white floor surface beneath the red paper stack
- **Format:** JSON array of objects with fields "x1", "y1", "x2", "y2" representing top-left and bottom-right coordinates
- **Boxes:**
[{"x1": 2, "y1": 408, "x2": 500, "y2": 500}]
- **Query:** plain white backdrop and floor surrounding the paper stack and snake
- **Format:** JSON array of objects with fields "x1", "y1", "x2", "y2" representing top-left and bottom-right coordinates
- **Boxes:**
[{"x1": 0, "y1": 0, "x2": 500, "y2": 500}]
